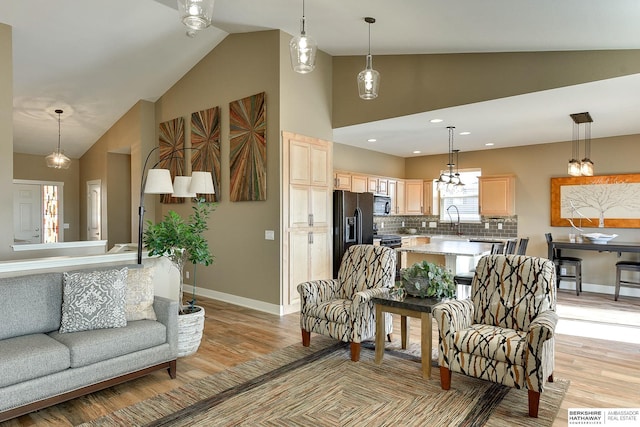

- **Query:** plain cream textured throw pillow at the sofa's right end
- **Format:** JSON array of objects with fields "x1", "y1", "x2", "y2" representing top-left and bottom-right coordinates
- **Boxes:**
[{"x1": 125, "y1": 267, "x2": 157, "y2": 322}]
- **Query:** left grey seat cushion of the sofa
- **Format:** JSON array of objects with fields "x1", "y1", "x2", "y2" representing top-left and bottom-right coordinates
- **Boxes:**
[{"x1": 0, "y1": 334, "x2": 70, "y2": 387}]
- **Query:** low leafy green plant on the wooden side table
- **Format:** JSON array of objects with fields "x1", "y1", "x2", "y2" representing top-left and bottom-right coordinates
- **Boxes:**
[{"x1": 394, "y1": 261, "x2": 456, "y2": 299}]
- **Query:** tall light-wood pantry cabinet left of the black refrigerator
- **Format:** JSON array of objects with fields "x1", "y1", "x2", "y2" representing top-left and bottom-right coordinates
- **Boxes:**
[{"x1": 281, "y1": 132, "x2": 333, "y2": 312}]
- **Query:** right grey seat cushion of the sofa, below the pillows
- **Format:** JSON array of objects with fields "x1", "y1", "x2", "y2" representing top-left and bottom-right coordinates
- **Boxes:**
[{"x1": 49, "y1": 320, "x2": 167, "y2": 368}]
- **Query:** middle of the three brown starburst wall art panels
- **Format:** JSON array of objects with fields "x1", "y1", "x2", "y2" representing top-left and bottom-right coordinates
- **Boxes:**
[{"x1": 191, "y1": 107, "x2": 221, "y2": 202}]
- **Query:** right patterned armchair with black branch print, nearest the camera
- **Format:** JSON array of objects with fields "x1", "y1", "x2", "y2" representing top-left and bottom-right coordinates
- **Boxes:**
[{"x1": 433, "y1": 255, "x2": 558, "y2": 417}]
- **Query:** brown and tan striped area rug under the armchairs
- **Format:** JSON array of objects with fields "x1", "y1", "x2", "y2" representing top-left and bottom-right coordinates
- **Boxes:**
[{"x1": 83, "y1": 336, "x2": 569, "y2": 427}]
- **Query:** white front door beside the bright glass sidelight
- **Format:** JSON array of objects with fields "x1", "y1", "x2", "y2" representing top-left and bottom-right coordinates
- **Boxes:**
[{"x1": 13, "y1": 184, "x2": 42, "y2": 243}]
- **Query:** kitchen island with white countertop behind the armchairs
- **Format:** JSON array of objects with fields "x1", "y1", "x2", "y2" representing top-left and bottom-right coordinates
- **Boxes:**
[{"x1": 397, "y1": 239, "x2": 491, "y2": 274}]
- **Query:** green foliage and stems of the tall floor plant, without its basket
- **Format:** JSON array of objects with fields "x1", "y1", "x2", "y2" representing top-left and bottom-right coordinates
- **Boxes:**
[{"x1": 144, "y1": 199, "x2": 215, "y2": 314}]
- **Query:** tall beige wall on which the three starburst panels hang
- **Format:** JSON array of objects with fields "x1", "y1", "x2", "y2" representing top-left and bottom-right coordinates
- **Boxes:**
[{"x1": 156, "y1": 31, "x2": 280, "y2": 304}]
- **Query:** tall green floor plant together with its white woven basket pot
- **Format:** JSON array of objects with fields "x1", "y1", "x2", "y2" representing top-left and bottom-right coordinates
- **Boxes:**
[{"x1": 144, "y1": 199, "x2": 214, "y2": 356}]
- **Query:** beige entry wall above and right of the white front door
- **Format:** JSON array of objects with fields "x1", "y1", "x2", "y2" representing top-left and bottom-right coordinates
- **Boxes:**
[{"x1": 13, "y1": 154, "x2": 80, "y2": 242}]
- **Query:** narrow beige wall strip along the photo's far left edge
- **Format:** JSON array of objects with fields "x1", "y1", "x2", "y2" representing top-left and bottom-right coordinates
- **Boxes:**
[{"x1": 0, "y1": 24, "x2": 13, "y2": 259}]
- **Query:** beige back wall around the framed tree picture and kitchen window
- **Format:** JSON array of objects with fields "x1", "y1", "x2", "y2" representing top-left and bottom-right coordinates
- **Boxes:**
[{"x1": 406, "y1": 135, "x2": 640, "y2": 285}]
